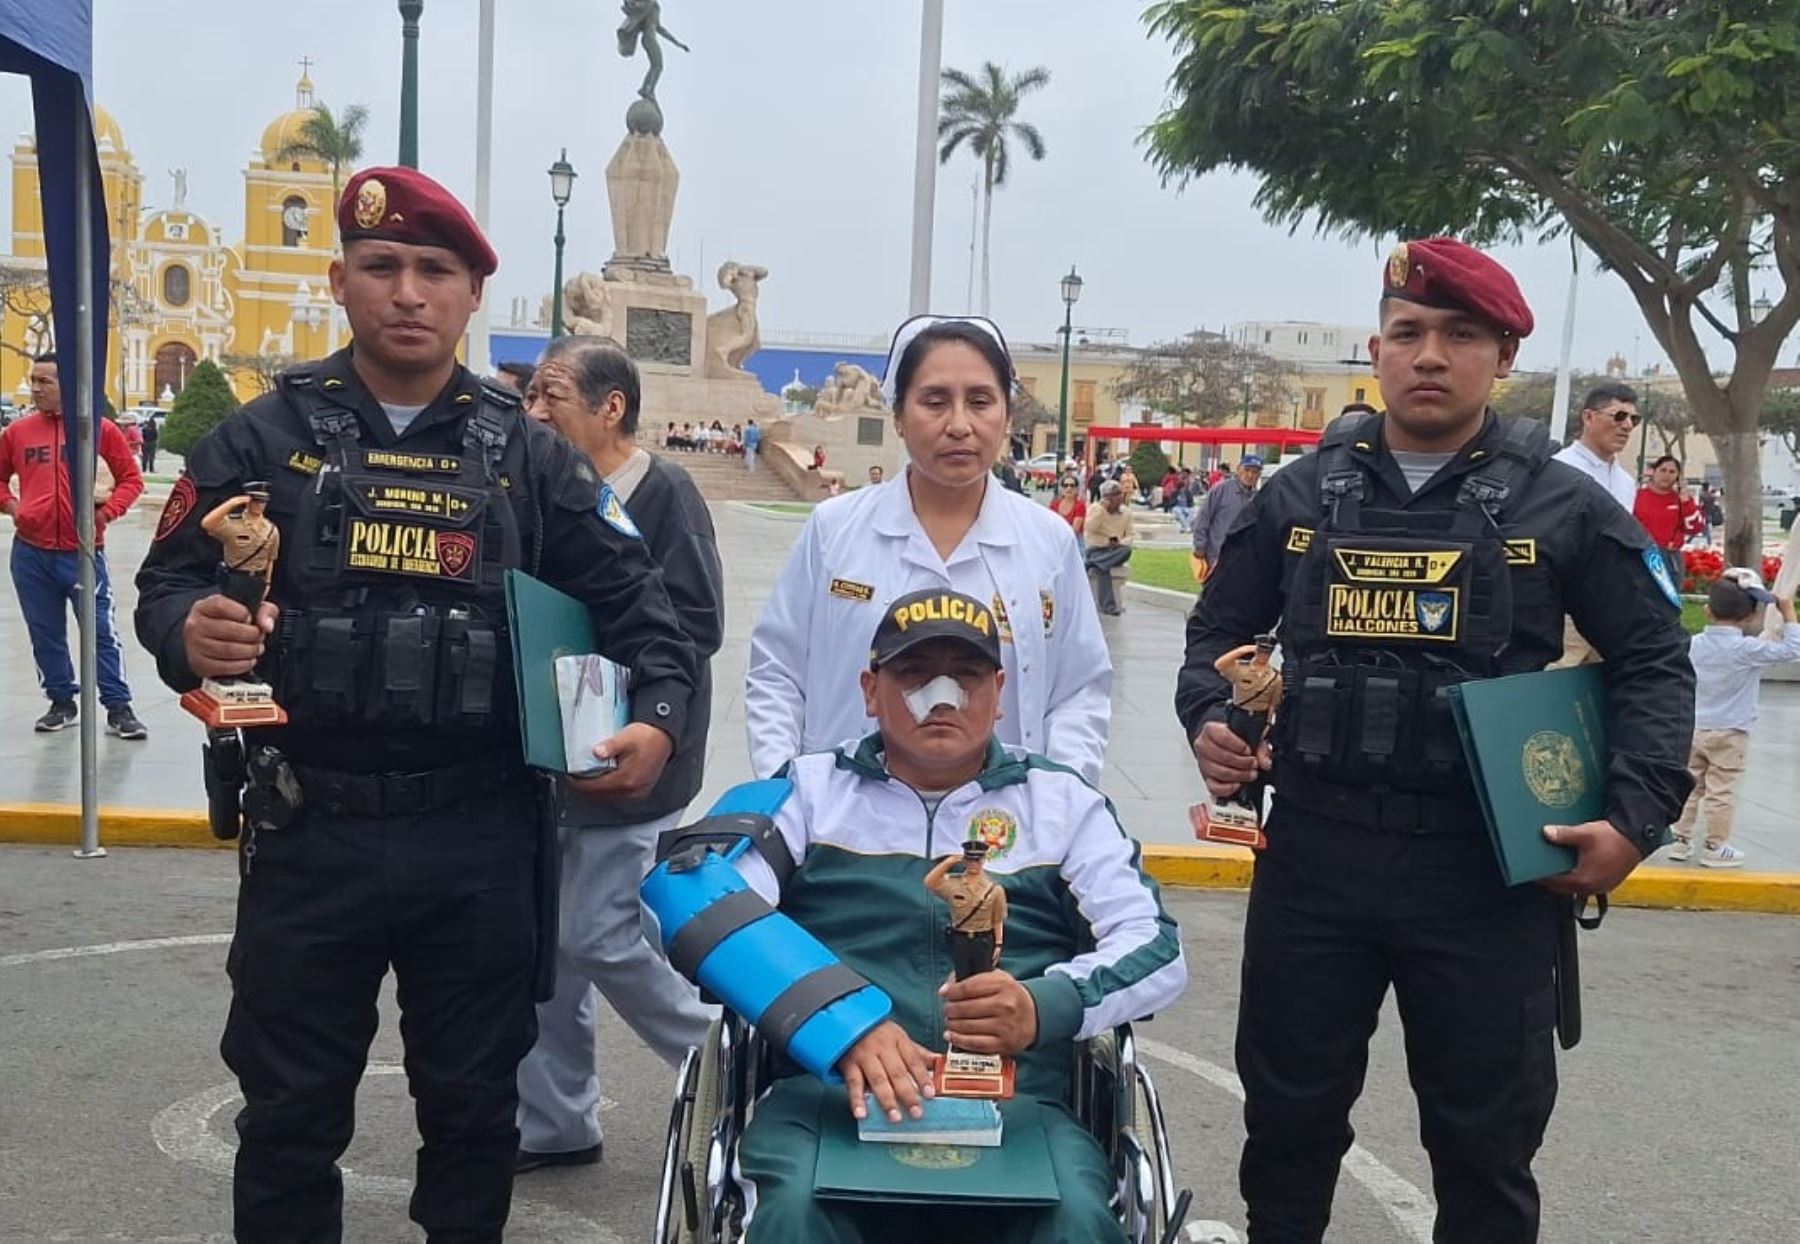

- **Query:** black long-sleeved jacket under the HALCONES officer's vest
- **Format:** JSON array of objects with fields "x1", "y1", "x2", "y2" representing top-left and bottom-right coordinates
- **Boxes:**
[{"x1": 1175, "y1": 414, "x2": 1694, "y2": 853}]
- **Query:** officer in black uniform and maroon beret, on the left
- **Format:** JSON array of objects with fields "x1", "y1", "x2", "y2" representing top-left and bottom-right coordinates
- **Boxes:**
[{"x1": 137, "y1": 169, "x2": 697, "y2": 1244}]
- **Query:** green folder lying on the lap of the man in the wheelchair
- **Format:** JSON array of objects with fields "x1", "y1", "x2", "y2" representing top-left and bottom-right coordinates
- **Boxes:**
[{"x1": 812, "y1": 1102, "x2": 1062, "y2": 1206}]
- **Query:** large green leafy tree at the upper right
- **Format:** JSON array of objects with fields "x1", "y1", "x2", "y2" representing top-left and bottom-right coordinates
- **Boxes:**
[{"x1": 1147, "y1": 0, "x2": 1800, "y2": 565}]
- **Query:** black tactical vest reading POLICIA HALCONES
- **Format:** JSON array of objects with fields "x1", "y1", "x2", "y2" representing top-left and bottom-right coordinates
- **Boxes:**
[{"x1": 1276, "y1": 414, "x2": 1550, "y2": 794}]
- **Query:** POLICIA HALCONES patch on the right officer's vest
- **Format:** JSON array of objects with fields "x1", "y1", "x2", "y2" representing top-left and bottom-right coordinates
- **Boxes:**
[{"x1": 1325, "y1": 547, "x2": 1467, "y2": 643}]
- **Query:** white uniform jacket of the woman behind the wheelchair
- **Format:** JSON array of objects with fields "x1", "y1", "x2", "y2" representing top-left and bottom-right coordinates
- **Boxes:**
[{"x1": 743, "y1": 475, "x2": 1112, "y2": 783}]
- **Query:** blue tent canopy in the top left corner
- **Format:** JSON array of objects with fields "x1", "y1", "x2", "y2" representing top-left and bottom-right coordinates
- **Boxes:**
[{"x1": 0, "y1": 0, "x2": 110, "y2": 421}]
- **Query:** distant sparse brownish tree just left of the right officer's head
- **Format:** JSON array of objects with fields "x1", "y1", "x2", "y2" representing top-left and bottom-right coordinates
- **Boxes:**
[{"x1": 1112, "y1": 331, "x2": 1298, "y2": 427}]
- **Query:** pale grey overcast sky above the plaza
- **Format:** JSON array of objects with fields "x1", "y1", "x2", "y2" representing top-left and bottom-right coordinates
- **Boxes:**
[{"x1": 0, "y1": 0, "x2": 1787, "y2": 369}]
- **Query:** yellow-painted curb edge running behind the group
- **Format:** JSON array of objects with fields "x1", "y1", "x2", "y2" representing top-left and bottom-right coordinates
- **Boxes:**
[{"x1": 0, "y1": 803, "x2": 1800, "y2": 916}]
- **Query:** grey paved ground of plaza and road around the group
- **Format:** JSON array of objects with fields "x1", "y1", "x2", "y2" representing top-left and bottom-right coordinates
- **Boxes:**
[{"x1": 0, "y1": 506, "x2": 1800, "y2": 1244}]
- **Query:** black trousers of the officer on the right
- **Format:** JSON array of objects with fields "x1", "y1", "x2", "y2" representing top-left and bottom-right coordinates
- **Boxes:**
[{"x1": 1237, "y1": 796, "x2": 1557, "y2": 1244}]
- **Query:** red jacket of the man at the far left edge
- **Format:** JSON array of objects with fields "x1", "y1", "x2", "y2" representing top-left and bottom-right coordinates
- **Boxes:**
[{"x1": 0, "y1": 409, "x2": 144, "y2": 553}]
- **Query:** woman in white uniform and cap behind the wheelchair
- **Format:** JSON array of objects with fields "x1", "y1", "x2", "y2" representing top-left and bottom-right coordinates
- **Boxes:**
[{"x1": 745, "y1": 317, "x2": 1112, "y2": 781}]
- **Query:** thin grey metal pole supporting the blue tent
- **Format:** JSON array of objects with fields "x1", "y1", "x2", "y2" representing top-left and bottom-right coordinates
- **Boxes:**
[{"x1": 72, "y1": 112, "x2": 106, "y2": 859}]
